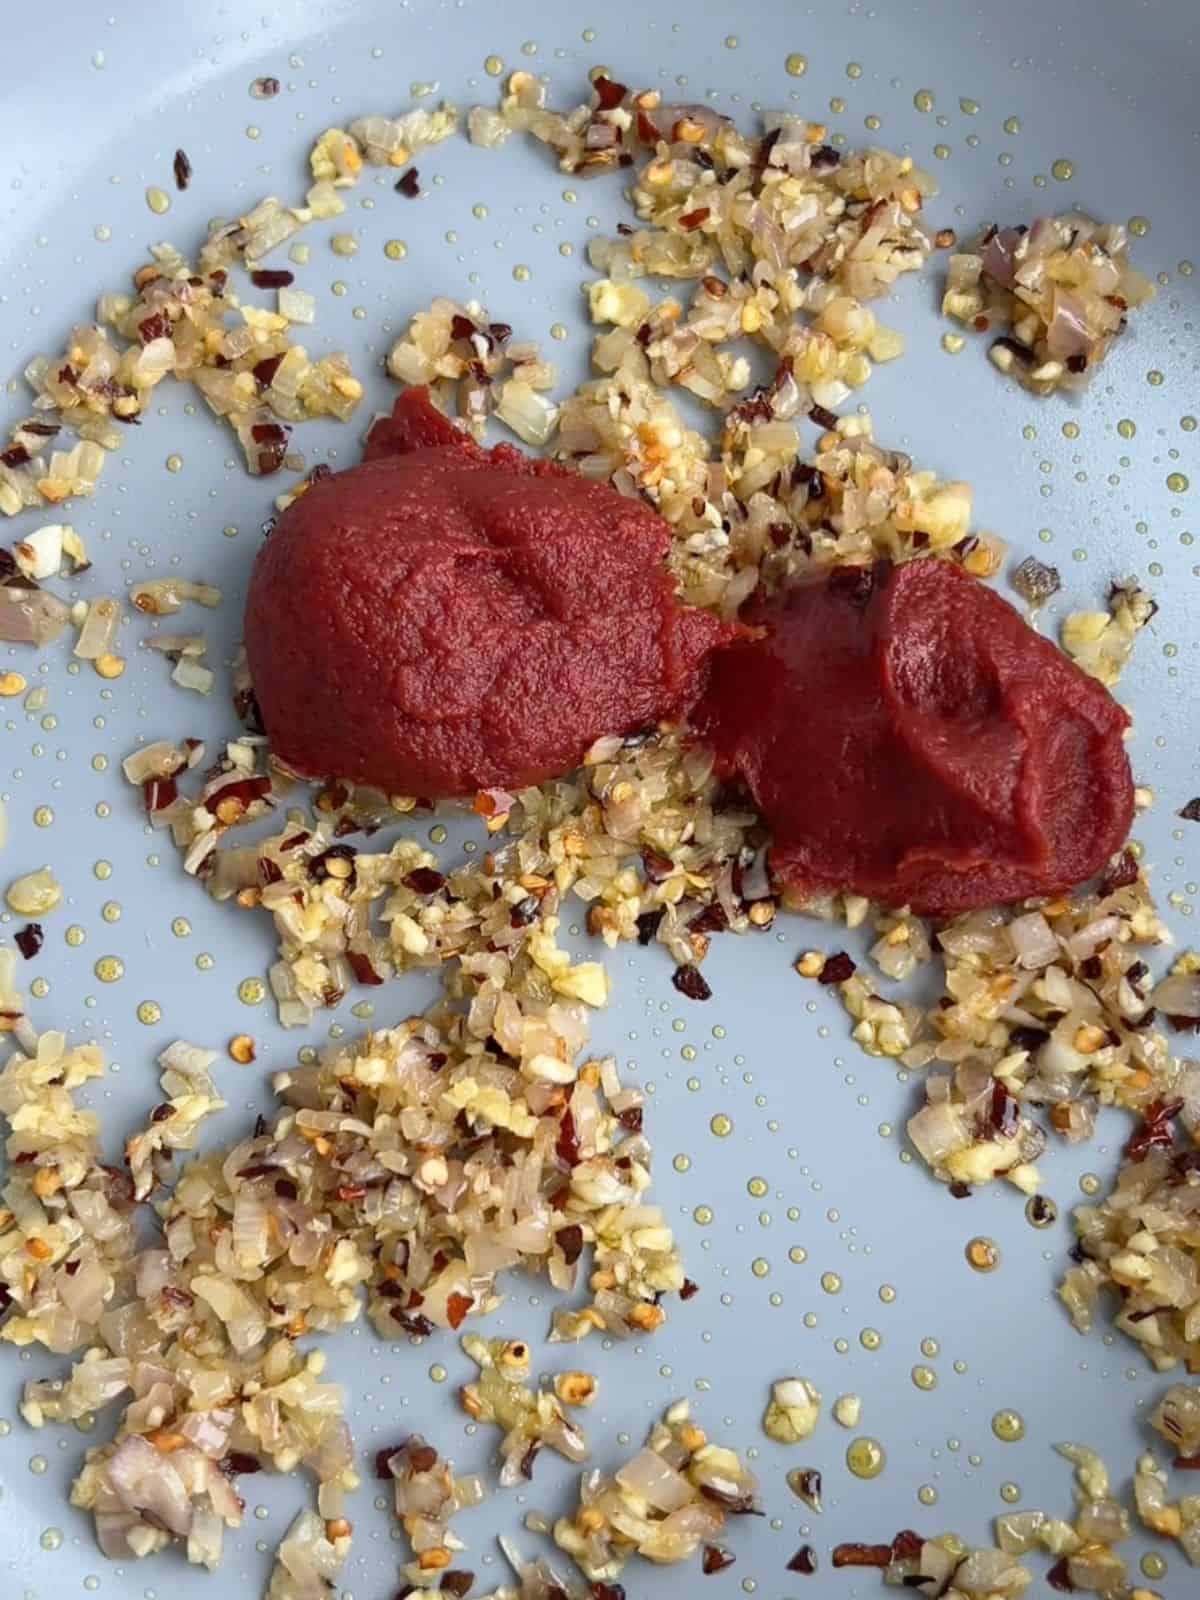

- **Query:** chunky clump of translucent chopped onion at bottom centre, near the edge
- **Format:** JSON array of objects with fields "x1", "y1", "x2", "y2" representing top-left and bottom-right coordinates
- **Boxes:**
[{"x1": 554, "y1": 1400, "x2": 758, "y2": 1584}]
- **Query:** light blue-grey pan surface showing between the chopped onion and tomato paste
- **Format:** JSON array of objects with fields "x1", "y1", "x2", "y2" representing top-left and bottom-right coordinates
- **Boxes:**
[{"x1": 0, "y1": 0, "x2": 1200, "y2": 1600}]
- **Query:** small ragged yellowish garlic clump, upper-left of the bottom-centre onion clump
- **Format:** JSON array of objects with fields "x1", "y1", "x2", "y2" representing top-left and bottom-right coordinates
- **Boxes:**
[{"x1": 459, "y1": 1334, "x2": 595, "y2": 1488}]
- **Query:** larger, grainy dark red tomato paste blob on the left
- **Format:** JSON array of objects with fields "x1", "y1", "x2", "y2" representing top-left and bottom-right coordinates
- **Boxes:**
[{"x1": 245, "y1": 389, "x2": 739, "y2": 798}]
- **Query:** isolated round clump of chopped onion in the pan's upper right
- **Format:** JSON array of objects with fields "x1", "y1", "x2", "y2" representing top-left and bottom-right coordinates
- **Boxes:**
[{"x1": 942, "y1": 214, "x2": 1155, "y2": 395}]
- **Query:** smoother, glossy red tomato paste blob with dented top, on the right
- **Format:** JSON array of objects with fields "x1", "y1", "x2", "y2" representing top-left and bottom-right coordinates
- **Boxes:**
[{"x1": 694, "y1": 560, "x2": 1133, "y2": 915}]
